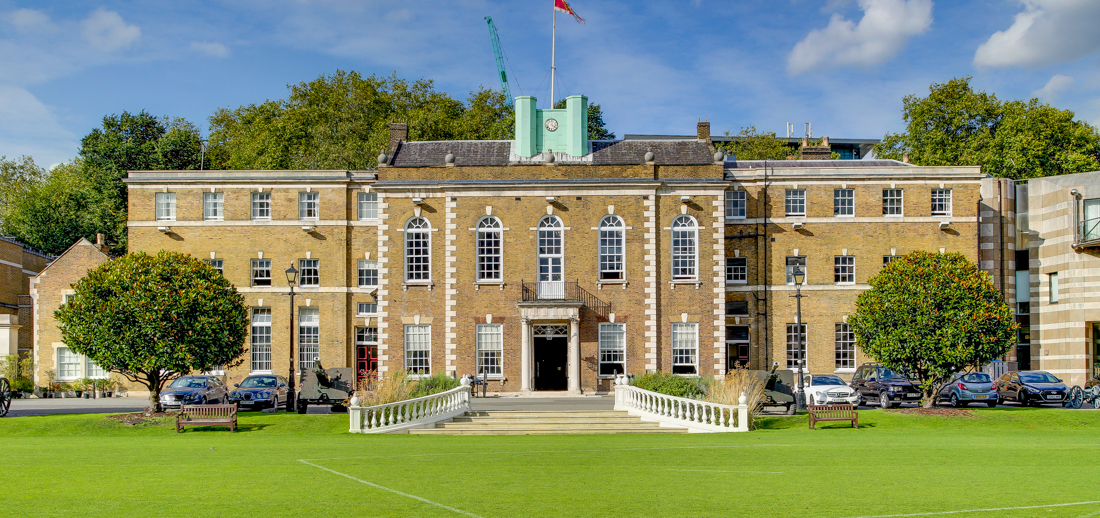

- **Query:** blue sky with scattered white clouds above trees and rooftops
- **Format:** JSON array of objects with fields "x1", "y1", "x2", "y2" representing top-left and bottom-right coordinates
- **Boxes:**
[{"x1": 0, "y1": 0, "x2": 1100, "y2": 165}]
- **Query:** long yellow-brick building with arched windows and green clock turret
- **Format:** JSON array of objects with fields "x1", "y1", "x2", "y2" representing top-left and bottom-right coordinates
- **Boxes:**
[{"x1": 113, "y1": 96, "x2": 981, "y2": 393}]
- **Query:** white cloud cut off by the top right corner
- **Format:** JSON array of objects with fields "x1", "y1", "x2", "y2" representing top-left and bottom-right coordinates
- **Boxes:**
[{"x1": 974, "y1": 0, "x2": 1100, "y2": 68}]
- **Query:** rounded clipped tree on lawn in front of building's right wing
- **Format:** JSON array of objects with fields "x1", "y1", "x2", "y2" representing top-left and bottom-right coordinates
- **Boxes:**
[{"x1": 848, "y1": 252, "x2": 1016, "y2": 408}]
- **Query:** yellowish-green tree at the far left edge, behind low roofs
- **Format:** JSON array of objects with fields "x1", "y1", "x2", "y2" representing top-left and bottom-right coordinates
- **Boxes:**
[{"x1": 0, "y1": 162, "x2": 100, "y2": 254}]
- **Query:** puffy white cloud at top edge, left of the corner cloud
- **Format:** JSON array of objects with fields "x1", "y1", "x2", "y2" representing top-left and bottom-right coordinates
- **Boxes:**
[{"x1": 787, "y1": 0, "x2": 932, "y2": 75}]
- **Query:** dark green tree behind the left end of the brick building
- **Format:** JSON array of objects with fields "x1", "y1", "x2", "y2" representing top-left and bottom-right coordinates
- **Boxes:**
[{"x1": 79, "y1": 111, "x2": 201, "y2": 252}]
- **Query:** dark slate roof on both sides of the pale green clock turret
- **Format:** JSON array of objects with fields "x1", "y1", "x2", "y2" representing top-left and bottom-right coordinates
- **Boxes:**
[{"x1": 389, "y1": 140, "x2": 714, "y2": 167}]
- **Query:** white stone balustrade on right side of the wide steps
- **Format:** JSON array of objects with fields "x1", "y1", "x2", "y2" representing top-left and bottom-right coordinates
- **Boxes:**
[{"x1": 615, "y1": 375, "x2": 749, "y2": 433}]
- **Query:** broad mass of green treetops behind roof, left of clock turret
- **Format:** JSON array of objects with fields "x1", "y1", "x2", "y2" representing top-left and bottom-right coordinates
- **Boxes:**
[{"x1": 209, "y1": 70, "x2": 515, "y2": 169}]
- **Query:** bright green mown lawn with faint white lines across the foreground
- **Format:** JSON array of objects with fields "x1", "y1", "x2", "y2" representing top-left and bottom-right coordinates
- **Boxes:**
[{"x1": 0, "y1": 408, "x2": 1100, "y2": 518}]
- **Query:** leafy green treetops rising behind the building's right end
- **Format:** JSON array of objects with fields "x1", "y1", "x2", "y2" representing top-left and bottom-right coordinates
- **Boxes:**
[{"x1": 875, "y1": 77, "x2": 1100, "y2": 179}]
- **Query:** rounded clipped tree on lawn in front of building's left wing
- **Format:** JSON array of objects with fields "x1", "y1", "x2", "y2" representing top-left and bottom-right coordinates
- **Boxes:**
[{"x1": 54, "y1": 251, "x2": 249, "y2": 411}]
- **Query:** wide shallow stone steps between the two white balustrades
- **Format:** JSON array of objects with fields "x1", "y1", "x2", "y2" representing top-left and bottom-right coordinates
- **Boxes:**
[{"x1": 409, "y1": 410, "x2": 688, "y2": 436}]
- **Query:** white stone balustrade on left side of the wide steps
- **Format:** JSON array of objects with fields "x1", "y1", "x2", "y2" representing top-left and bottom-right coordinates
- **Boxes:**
[{"x1": 348, "y1": 377, "x2": 470, "y2": 433}]
